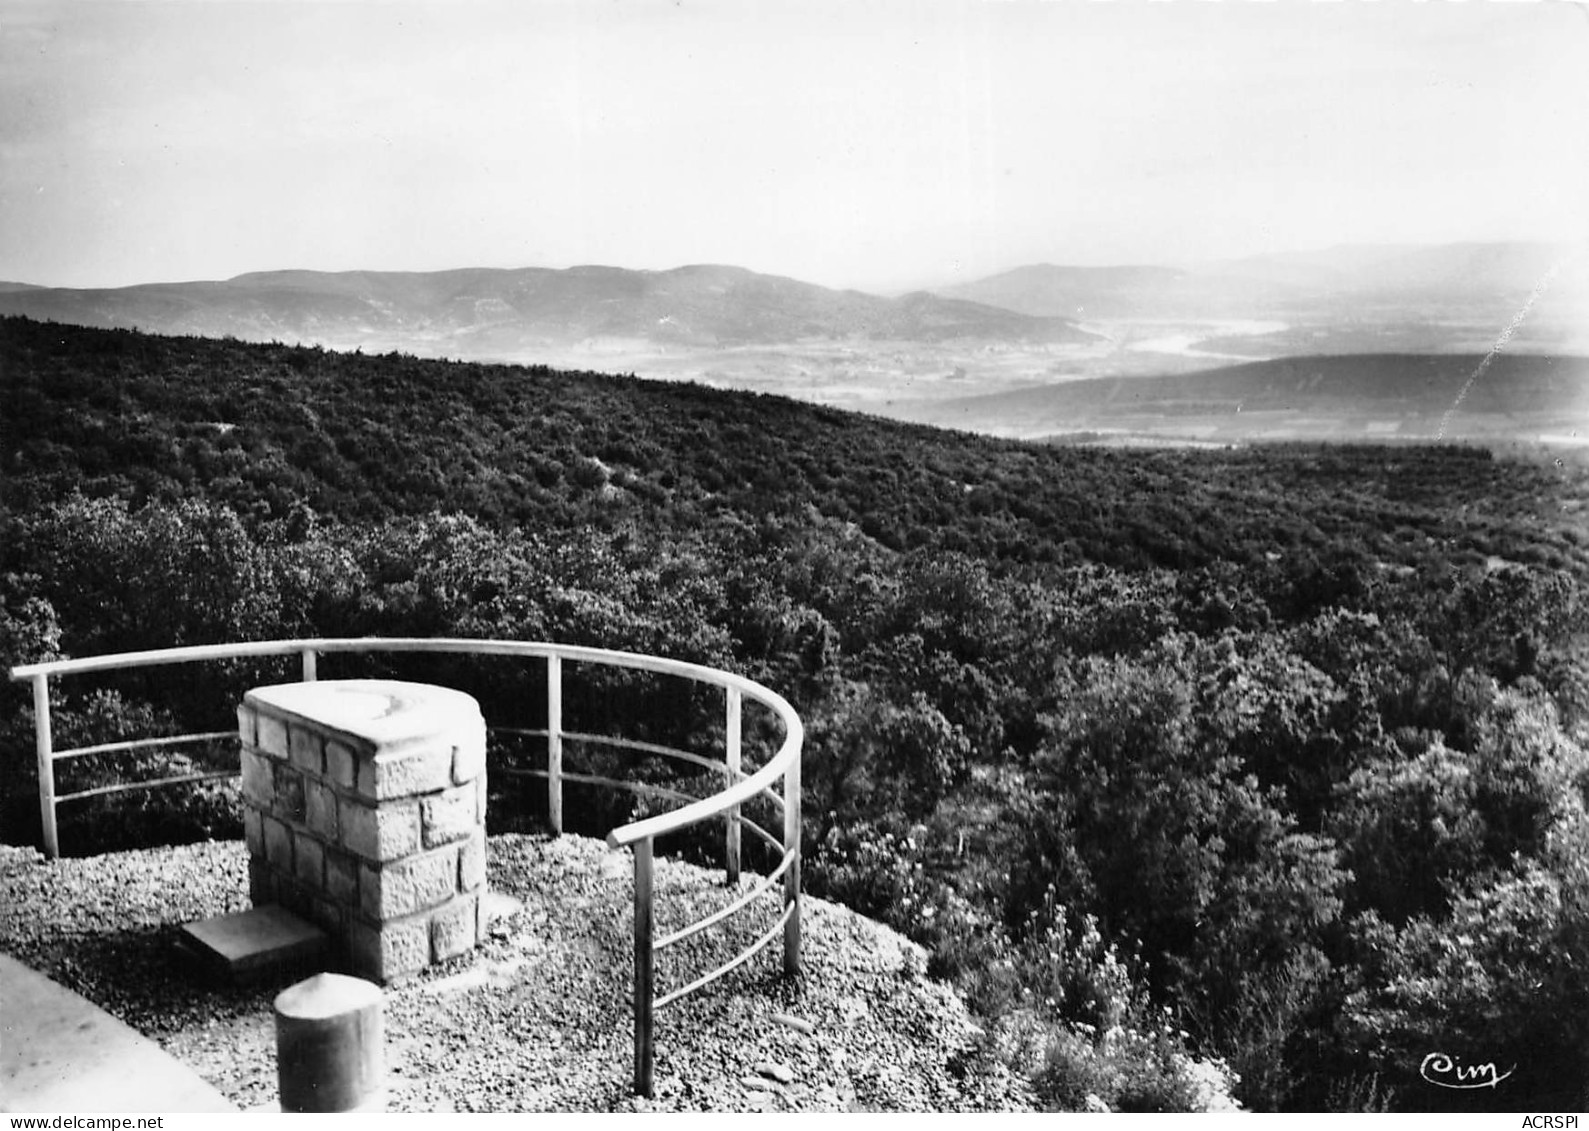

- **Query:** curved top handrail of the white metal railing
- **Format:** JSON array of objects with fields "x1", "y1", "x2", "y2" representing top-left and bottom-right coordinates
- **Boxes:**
[{"x1": 11, "y1": 637, "x2": 804, "y2": 848}]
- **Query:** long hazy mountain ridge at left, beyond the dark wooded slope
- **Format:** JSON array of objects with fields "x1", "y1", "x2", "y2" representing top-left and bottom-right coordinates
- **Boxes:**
[{"x1": 0, "y1": 265, "x2": 1092, "y2": 357}]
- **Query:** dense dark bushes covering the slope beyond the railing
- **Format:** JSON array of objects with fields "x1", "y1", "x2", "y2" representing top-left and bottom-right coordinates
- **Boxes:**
[{"x1": 0, "y1": 319, "x2": 1589, "y2": 1110}]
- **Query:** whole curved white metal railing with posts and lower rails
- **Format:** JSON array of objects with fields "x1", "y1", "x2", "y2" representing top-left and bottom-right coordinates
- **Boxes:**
[{"x1": 11, "y1": 637, "x2": 804, "y2": 1096}]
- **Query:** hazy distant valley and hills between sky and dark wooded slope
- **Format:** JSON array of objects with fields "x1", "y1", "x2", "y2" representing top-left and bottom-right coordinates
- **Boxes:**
[{"x1": 0, "y1": 243, "x2": 1589, "y2": 448}]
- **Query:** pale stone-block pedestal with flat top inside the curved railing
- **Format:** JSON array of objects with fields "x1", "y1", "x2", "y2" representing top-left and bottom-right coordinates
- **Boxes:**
[{"x1": 237, "y1": 680, "x2": 486, "y2": 983}]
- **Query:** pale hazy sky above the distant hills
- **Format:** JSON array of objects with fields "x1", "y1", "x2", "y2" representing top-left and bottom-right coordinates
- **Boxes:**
[{"x1": 0, "y1": 0, "x2": 1589, "y2": 288}]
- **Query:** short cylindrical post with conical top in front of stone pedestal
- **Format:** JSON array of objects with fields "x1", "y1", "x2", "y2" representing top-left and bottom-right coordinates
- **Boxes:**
[{"x1": 275, "y1": 974, "x2": 386, "y2": 1112}]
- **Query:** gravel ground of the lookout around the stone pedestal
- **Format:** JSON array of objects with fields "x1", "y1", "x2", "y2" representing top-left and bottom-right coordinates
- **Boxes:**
[{"x1": 0, "y1": 836, "x2": 1033, "y2": 1112}]
